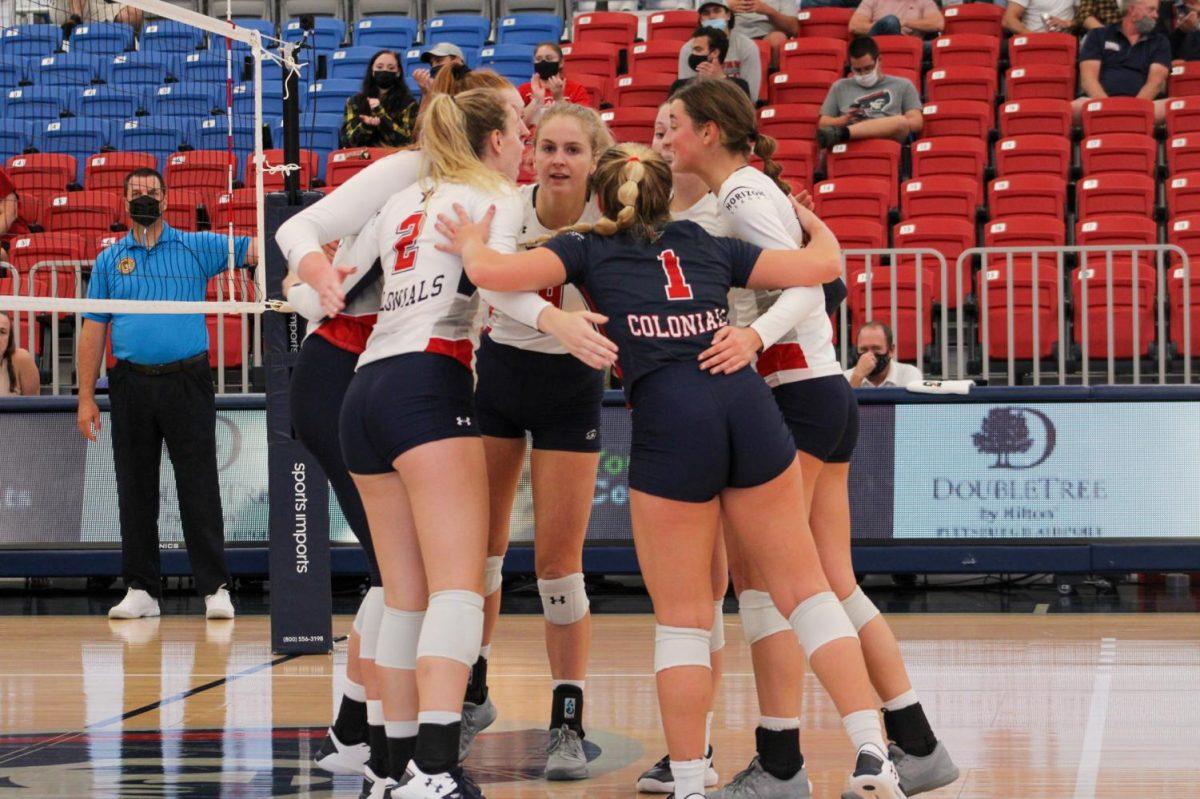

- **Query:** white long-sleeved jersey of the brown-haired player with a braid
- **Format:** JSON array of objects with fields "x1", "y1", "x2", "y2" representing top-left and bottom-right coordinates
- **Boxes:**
[{"x1": 718, "y1": 167, "x2": 841, "y2": 388}]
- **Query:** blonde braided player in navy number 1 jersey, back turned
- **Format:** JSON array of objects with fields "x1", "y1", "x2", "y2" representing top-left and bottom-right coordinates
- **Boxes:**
[{"x1": 438, "y1": 144, "x2": 902, "y2": 799}]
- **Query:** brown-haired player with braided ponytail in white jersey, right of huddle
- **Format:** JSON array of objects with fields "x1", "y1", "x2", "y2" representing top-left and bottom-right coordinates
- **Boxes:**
[{"x1": 666, "y1": 76, "x2": 958, "y2": 799}]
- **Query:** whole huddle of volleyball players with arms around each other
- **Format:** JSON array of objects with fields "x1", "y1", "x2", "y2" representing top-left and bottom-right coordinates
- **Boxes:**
[{"x1": 277, "y1": 71, "x2": 958, "y2": 799}]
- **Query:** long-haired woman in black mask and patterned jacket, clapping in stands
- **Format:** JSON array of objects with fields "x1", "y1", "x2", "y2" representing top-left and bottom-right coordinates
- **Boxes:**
[{"x1": 340, "y1": 50, "x2": 416, "y2": 148}]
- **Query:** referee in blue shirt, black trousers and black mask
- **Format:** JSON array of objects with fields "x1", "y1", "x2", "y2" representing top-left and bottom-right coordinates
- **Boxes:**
[{"x1": 77, "y1": 169, "x2": 254, "y2": 619}]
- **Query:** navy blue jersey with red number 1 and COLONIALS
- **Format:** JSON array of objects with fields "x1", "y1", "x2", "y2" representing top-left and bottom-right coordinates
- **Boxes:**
[{"x1": 544, "y1": 222, "x2": 762, "y2": 397}]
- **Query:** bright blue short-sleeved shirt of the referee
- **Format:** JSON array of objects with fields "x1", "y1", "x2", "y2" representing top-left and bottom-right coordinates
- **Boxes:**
[{"x1": 83, "y1": 222, "x2": 250, "y2": 365}]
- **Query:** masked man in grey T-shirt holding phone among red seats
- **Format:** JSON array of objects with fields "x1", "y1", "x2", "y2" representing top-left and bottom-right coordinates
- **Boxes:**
[{"x1": 817, "y1": 36, "x2": 925, "y2": 148}]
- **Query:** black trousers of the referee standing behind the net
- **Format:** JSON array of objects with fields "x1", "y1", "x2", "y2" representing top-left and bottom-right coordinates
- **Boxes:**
[{"x1": 108, "y1": 359, "x2": 230, "y2": 597}]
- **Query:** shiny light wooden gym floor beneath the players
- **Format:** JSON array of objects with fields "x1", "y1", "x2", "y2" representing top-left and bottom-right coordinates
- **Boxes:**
[{"x1": 0, "y1": 613, "x2": 1200, "y2": 799}]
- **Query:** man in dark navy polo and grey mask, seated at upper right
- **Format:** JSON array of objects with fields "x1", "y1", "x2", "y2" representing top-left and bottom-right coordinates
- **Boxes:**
[{"x1": 1073, "y1": 0, "x2": 1171, "y2": 121}]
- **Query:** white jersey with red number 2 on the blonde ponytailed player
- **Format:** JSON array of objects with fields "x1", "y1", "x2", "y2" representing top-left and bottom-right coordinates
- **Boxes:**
[{"x1": 359, "y1": 182, "x2": 523, "y2": 368}]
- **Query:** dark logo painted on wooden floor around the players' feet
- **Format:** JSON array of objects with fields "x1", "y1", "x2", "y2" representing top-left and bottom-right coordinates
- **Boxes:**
[{"x1": 0, "y1": 727, "x2": 642, "y2": 799}]
